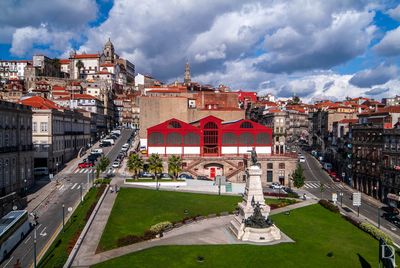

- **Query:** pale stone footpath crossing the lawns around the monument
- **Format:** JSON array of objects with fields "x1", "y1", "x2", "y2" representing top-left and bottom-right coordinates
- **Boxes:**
[{"x1": 72, "y1": 193, "x2": 317, "y2": 267}]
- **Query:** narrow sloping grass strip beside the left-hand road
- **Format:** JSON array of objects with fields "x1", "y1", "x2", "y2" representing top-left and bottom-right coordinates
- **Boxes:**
[{"x1": 38, "y1": 186, "x2": 104, "y2": 267}]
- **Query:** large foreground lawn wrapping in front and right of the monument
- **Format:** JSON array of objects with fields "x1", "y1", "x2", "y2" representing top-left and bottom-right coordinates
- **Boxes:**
[{"x1": 94, "y1": 204, "x2": 392, "y2": 268}]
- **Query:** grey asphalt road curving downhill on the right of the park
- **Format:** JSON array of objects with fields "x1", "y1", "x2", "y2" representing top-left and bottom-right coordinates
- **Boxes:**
[{"x1": 301, "y1": 153, "x2": 400, "y2": 244}]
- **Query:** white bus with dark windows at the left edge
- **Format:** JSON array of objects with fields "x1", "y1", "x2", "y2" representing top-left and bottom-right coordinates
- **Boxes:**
[{"x1": 0, "y1": 210, "x2": 31, "y2": 262}]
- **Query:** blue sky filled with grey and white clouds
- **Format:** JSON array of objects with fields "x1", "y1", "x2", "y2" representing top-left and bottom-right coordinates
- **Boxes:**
[{"x1": 0, "y1": 0, "x2": 400, "y2": 102}]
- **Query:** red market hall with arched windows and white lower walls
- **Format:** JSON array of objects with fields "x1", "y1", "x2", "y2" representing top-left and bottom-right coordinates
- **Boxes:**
[{"x1": 142, "y1": 116, "x2": 272, "y2": 157}]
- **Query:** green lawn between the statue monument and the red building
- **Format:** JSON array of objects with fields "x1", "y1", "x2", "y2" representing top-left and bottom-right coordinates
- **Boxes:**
[{"x1": 99, "y1": 188, "x2": 242, "y2": 251}]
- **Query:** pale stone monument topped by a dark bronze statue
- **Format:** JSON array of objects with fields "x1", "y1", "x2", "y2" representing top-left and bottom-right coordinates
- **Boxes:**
[{"x1": 230, "y1": 148, "x2": 281, "y2": 242}]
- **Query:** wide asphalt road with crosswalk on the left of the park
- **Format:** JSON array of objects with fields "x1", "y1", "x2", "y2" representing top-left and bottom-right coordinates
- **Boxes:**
[{"x1": 0, "y1": 130, "x2": 133, "y2": 267}]
